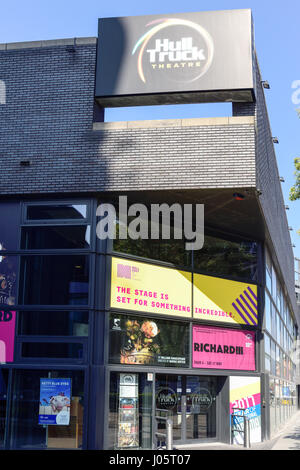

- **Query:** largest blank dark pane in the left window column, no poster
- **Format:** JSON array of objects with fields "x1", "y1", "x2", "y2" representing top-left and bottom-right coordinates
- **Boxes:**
[{"x1": 20, "y1": 255, "x2": 89, "y2": 305}]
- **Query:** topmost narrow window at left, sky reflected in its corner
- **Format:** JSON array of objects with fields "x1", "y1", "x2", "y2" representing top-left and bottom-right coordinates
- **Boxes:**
[{"x1": 26, "y1": 204, "x2": 87, "y2": 220}]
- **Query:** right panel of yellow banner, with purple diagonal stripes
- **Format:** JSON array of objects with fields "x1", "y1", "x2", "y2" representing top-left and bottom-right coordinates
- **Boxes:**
[{"x1": 193, "y1": 274, "x2": 258, "y2": 326}]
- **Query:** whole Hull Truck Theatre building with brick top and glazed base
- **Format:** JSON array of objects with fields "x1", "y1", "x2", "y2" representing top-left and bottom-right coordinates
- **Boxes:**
[{"x1": 0, "y1": 10, "x2": 298, "y2": 450}]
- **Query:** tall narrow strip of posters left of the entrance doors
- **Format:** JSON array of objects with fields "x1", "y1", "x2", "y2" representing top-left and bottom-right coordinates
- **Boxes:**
[{"x1": 118, "y1": 373, "x2": 139, "y2": 448}]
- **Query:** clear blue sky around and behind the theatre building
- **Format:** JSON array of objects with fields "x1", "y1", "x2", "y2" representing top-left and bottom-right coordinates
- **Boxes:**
[{"x1": 0, "y1": 0, "x2": 300, "y2": 264}]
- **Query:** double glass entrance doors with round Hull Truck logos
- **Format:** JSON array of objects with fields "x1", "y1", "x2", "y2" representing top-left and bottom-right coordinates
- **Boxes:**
[{"x1": 155, "y1": 374, "x2": 217, "y2": 442}]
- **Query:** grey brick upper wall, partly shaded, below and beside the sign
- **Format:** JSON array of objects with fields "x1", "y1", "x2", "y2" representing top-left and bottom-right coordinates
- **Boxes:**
[{"x1": 0, "y1": 42, "x2": 256, "y2": 195}]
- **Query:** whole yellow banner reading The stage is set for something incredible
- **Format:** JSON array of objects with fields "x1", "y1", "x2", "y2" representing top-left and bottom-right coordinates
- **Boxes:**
[{"x1": 110, "y1": 257, "x2": 258, "y2": 326}]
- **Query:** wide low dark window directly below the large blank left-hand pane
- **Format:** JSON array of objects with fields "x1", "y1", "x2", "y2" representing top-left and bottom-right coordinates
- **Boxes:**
[{"x1": 18, "y1": 310, "x2": 89, "y2": 336}]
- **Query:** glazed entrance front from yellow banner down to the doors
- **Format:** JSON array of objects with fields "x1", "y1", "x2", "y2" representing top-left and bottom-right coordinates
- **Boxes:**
[{"x1": 105, "y1": 256, "x2": 262, "y2": 449}]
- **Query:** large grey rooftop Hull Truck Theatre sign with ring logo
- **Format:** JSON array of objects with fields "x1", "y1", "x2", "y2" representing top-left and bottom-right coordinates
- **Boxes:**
[{"x1": 96, "y1": 10, "x2": 254, "y2": 107}]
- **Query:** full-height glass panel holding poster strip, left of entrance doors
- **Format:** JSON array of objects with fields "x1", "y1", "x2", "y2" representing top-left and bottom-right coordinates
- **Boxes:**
[{"x1": 107, "y1": 372, "x2": 152, "y2": 449}]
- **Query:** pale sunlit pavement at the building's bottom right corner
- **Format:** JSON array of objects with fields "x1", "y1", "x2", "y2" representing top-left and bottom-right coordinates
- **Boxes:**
[{"x1": 174, "y1": 410, "x2": 300, "y2": 451}]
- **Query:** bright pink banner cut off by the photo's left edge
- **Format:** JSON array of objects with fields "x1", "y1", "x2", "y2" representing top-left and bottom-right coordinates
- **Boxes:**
[{"x1": 0, "y1": 311, "x2": 16, "y2": 363}]
